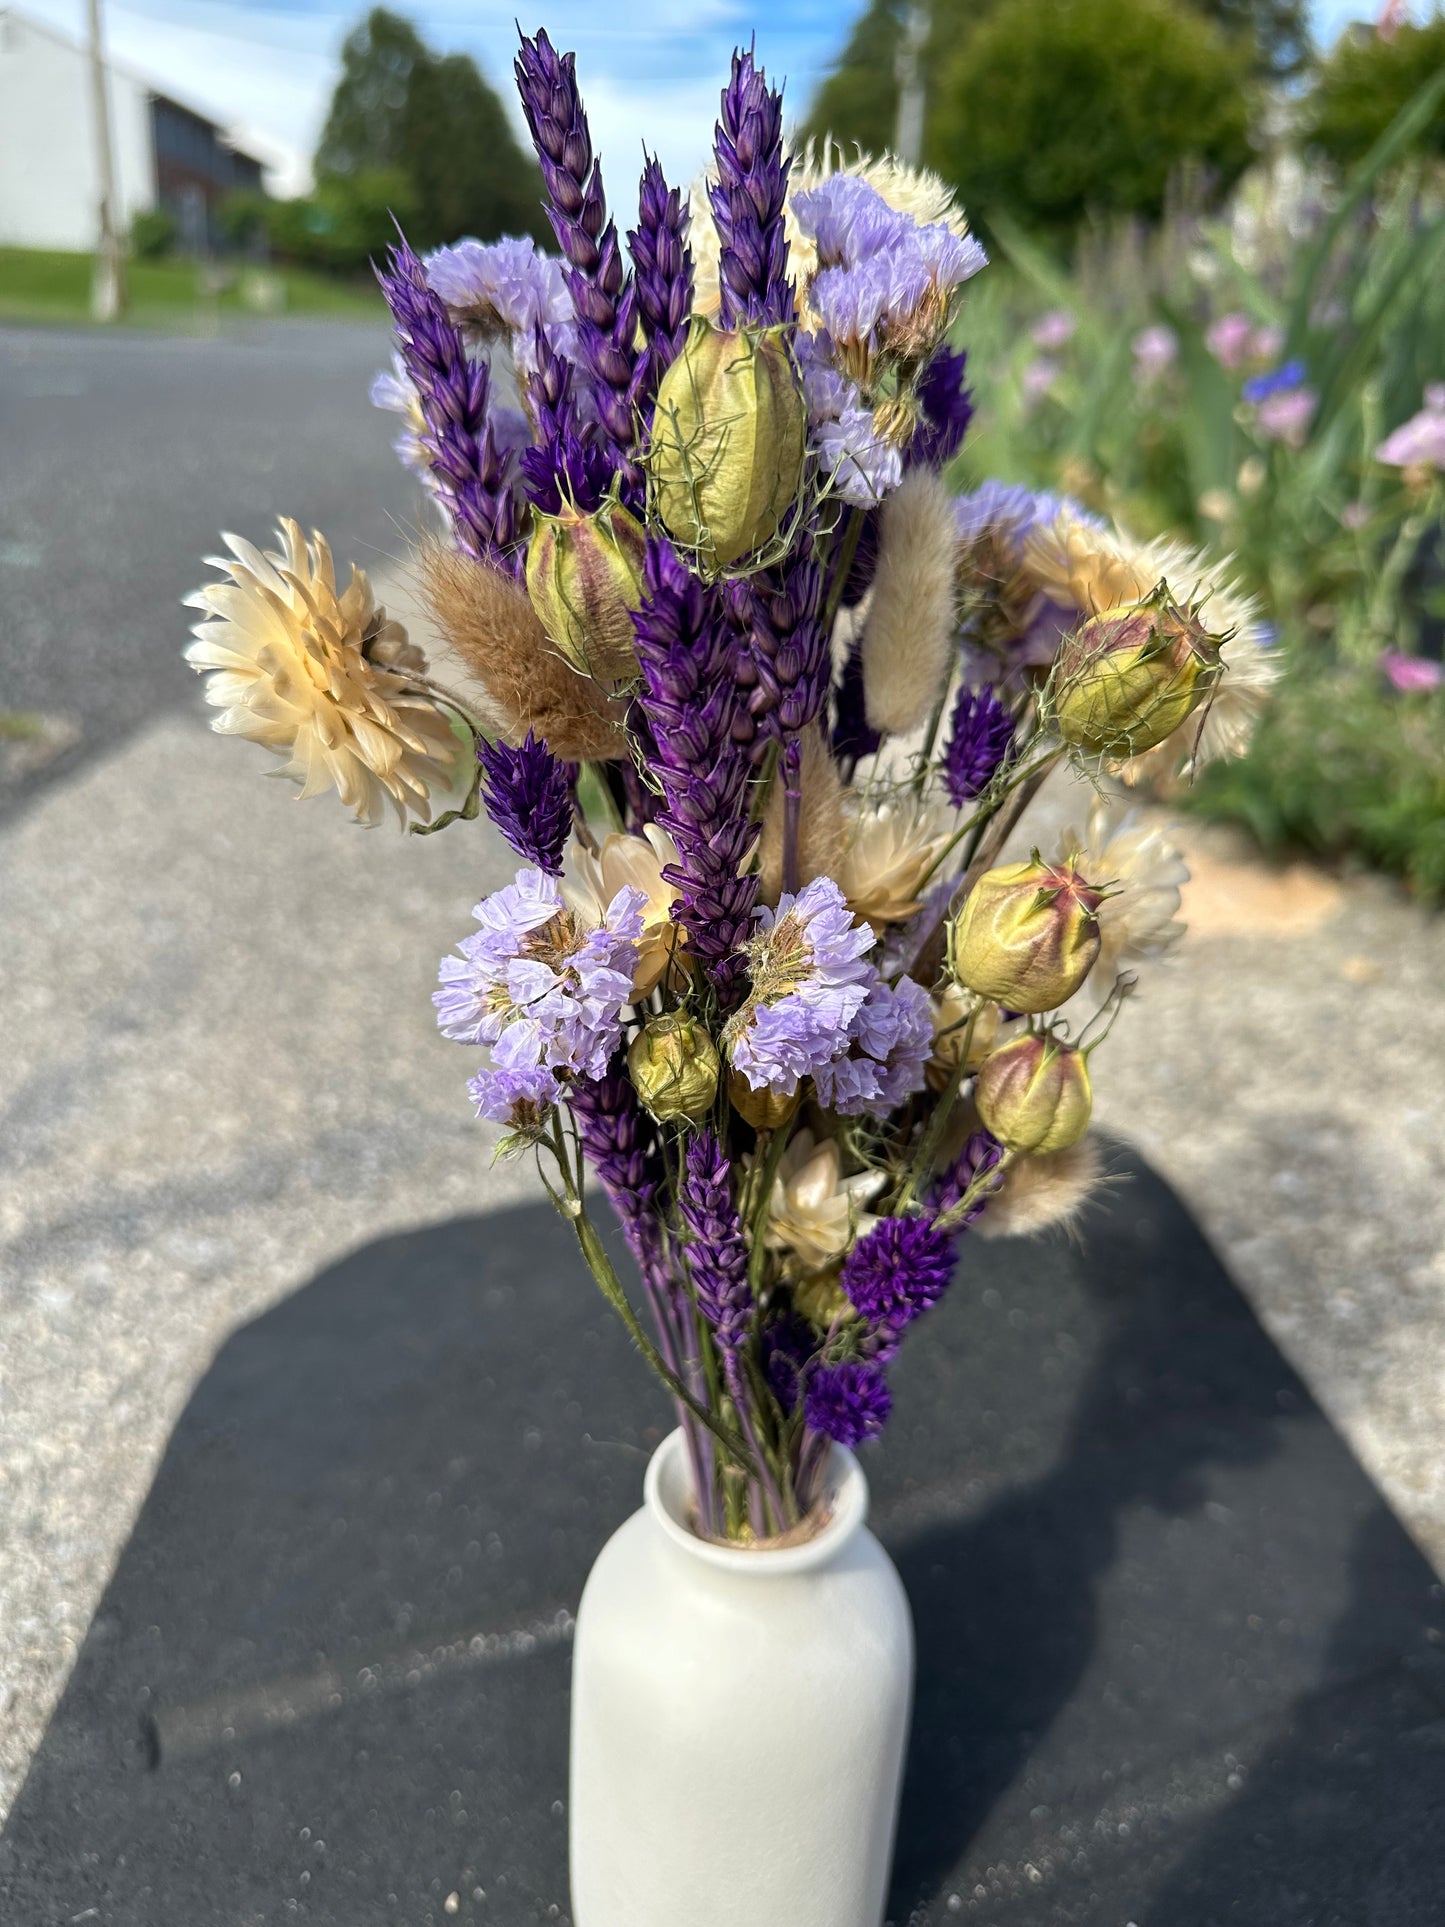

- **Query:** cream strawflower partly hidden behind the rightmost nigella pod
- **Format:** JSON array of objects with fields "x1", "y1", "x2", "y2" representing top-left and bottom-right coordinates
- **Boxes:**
[{"x1": 1021, "y1": 509, "x2": 1279, "y2": 782}]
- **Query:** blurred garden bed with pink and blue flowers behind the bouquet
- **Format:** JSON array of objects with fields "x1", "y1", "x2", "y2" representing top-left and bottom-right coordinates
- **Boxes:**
[{"x1": 959, "y1": 69, "x2": 1445, "y2": 904}]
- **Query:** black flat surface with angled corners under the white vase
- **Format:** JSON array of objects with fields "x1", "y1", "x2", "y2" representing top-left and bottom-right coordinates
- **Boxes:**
[{"x1": 0, "y1": 1160, "x2": 1445, "y2": 1927}]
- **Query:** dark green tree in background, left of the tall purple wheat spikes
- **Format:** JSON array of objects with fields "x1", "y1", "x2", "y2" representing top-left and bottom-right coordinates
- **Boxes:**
[{"x1": 316, "y1": 8, "x2": 549, "y2": 247}]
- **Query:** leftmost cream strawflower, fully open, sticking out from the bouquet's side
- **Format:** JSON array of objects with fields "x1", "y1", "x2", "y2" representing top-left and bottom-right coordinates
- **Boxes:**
[{"x1": 185, "y1": 518, "x2": 459, "y2": 823}]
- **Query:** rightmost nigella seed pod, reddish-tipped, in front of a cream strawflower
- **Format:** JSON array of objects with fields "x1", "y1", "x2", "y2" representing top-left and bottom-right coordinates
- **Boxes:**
[{"x1": 1050, "y1": 584, "x2": 1222, "y2": 757}]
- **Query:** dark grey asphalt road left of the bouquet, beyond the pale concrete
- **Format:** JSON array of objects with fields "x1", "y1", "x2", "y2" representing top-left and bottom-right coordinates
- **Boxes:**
[{"x1": 0, "y1": 322, "x2": 414, "y2": 811}]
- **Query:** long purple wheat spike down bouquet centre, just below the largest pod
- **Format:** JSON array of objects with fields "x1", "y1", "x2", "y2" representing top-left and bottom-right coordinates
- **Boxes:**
[{"x1": 632, "y1": 541, "x2": 757, "y2": 1006}]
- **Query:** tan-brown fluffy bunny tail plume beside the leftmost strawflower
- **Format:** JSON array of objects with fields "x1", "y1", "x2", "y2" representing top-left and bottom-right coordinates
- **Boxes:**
[{"x1": 416, "y1": 541, "x2": 626, "y2": 763}]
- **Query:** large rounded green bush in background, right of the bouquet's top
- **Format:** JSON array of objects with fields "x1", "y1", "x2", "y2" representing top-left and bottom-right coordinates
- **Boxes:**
[{"x1": 927, "y1": 0, "x2": 1250, "y2": 227}]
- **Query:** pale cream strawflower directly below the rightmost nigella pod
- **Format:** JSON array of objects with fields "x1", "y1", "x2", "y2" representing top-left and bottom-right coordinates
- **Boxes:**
[{"x1": 1056, "y1": 796, "x2": 1189, "y2": 998}]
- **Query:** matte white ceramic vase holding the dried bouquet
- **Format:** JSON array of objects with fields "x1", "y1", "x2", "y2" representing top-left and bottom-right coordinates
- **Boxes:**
[{"x1": 570, "y1": 1432, "x2": 913, "y2": 1927}]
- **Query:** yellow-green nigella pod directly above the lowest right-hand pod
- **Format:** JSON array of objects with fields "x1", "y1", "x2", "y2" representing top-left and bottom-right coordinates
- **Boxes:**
[{"x1": 948, "y1": 852, "x2": 1104, "y2": 1012}]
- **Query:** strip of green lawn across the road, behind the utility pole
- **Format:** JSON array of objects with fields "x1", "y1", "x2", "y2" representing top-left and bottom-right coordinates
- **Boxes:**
[{"x1": 0, "y1": 247, "x2": 385, "y2": 328}]
